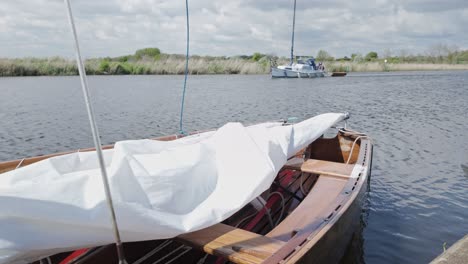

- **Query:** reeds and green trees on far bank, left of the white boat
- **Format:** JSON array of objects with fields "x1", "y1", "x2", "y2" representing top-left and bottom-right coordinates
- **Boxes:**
[{"x1": 0, "y1": 48, "x2": 270, "y2": 76}]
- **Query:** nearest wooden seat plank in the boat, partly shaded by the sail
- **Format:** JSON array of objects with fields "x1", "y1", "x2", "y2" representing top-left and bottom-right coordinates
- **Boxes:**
[{"x1": 176, "y1": 224, "x2": 285, "y2": 264}]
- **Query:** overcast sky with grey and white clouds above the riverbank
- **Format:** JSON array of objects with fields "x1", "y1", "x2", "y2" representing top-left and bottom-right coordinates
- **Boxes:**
[{"x1": 0, "y1": 0, "x2": 468, "y2": 57}]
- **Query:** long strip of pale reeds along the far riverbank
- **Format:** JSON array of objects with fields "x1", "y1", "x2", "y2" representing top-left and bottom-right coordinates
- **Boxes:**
[{"x1": 0, "y1": 54, "x2": 468, "y2": 76}]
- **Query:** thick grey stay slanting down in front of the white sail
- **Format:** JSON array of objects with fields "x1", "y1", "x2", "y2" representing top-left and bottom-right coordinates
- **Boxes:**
[{"x1": 64, "y1": 0, "x2": 127, "y2": 264}]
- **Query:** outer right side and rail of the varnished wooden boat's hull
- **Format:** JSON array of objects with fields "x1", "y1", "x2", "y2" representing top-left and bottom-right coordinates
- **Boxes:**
[{"x1": 270, "y1": 135, "x2": 372, "y2": 263}]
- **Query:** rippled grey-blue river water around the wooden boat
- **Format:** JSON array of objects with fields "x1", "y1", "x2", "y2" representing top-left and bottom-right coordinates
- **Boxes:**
[{"x1": 0, "y1": 71, "x2": 468, "y2": 263}]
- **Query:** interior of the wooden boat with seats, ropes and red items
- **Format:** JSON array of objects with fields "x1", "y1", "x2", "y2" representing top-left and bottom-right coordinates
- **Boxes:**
[{"x1": 0, "y1": 128, "x2": 372, "y2": 264}]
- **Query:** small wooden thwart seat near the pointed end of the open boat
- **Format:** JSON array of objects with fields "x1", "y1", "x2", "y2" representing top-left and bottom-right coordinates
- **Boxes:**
[{"x1": 284, "y1": 158, "x2": 354, "y2": 178}]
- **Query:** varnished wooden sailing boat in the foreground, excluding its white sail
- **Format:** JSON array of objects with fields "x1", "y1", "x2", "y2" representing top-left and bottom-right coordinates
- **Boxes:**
[{"x1": 0, "y1": 125, "x2": 372, "y2": 264}]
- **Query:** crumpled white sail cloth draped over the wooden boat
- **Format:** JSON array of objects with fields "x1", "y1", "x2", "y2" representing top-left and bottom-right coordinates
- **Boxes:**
[{"x1": 0, "y1": 113, "x2": 344, "y2": 263}]
